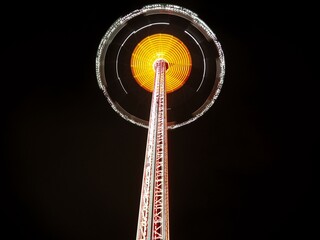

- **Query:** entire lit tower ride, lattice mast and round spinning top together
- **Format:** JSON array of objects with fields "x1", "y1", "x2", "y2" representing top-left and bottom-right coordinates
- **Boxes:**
[{"x1": 96, "y1": 4, "x2": 225, "y2": 240}]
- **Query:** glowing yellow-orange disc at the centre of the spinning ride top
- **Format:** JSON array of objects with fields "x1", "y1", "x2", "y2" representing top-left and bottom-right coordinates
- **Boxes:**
[{"x1": 130, "y1": 33, "x2": 192, "y2": 93}]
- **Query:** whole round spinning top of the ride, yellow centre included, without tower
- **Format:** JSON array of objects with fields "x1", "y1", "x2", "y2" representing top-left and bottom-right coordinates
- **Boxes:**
[{"x1": 96, "y1": 4, "x2": 225, "y2": 129}]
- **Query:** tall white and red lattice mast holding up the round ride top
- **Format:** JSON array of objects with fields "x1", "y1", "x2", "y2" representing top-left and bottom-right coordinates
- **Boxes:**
[{"x1": 136, "y1": 59, "x2": 169, "y2": 240}]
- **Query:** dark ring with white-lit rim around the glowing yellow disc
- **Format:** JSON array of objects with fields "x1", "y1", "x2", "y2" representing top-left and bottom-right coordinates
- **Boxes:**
[{"x1": 96, "y1": 4, "x2": 225, "y2": 129}]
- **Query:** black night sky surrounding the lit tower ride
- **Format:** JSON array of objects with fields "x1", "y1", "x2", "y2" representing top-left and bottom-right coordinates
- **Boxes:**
[{"x1": 0, "y1": 0, "x2": 319, "y2": 240}]
